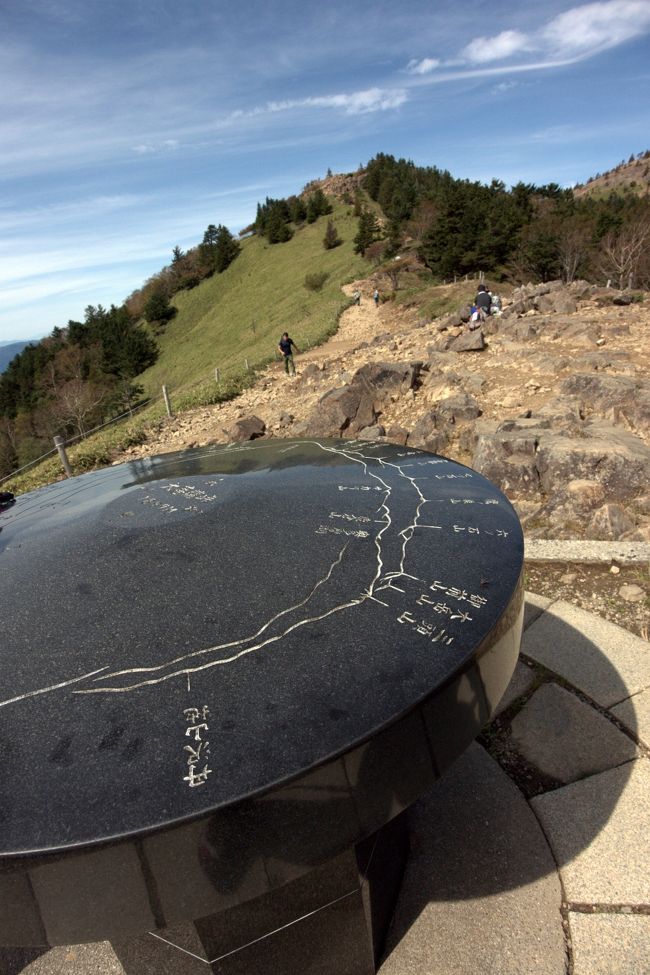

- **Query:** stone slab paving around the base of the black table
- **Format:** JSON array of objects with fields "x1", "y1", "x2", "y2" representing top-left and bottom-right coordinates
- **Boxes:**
[{"x1": 6, "y1": 594, "x2": 650, "y2": 975}]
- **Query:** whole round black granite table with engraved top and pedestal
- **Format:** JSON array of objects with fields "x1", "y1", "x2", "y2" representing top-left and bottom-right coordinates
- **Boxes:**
[{"x1": 0, "y1": 440, "x2": 523, "y2": 975}]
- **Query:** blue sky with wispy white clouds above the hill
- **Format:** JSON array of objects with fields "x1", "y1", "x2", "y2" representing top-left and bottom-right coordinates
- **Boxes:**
[{"x1": 0, "y1": 0, "x2": 650, "y2": 341}]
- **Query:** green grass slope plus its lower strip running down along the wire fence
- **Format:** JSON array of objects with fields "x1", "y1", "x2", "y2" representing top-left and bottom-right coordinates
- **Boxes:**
[{"x1": 3, "y1": 204, "x2": 369, "y2": 493}]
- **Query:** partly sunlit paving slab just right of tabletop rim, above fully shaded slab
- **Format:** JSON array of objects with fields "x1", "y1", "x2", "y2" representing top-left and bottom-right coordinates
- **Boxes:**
[{"x1": 521, "y1": 600, "x2": 650, "y2": 707}]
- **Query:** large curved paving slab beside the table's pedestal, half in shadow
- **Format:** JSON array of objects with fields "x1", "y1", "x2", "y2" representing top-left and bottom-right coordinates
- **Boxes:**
[{"x1": 379, "y1": 744, "x2": 565, "y2": 975}]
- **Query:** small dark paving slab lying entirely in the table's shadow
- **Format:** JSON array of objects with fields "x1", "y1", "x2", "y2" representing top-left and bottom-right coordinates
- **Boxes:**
[{"x1": 511, "y1": 683, "x2": 638, "y2": 783}]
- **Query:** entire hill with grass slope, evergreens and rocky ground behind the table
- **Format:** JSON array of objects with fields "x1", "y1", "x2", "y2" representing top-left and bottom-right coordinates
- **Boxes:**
[{"x1": 0, "y1": 154, "x2": 650, "y2": 556}]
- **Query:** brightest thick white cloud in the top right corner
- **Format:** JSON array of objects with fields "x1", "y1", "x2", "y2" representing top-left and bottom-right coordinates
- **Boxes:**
[{"x1": 542, "y1": 0, "x2": 650, "y2": 56}]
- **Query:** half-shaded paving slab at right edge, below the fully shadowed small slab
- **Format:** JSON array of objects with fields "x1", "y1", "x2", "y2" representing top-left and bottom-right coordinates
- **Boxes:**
[{"x1": 531, "y1": 758, "x2": 650, "y2": 904}]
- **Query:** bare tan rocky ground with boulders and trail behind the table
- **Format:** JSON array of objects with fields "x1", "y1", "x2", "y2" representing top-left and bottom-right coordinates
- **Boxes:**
[{"x1": 116, "y1": 273, "x2": 650, "y2": 541}]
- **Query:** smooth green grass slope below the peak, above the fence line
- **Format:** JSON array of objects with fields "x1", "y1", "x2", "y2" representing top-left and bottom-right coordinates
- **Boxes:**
[{"x1": 139, "y1": 204, "x2": 368, "y2": 395}]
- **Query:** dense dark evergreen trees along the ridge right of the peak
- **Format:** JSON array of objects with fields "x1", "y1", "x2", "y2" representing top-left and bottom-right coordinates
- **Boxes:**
[{"x1": 355, "y1": 154, "x2": 650, "y2": 285}]
